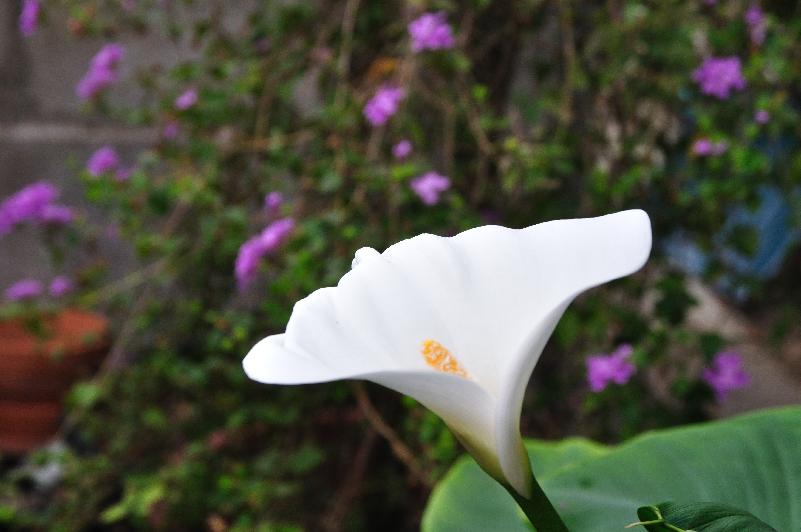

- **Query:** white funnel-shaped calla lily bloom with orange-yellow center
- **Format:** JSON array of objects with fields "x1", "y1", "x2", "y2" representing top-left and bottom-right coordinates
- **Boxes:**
[{"x1": 244, "y1": 210, "x2": 651, "y2": 497}]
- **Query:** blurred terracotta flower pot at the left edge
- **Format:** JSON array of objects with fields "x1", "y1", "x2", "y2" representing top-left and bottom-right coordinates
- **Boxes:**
[{"x1": 0, "y1": 309, "x2": 108, "y2": 454}]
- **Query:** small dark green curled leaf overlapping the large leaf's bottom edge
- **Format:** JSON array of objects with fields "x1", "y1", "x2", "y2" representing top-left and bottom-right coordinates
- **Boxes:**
[{"x1": 629, "y1": 502, "x2": 776, "y2": 532}]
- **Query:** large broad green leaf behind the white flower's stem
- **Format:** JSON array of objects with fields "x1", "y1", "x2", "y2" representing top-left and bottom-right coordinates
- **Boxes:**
[{"x1": 423, "y1": 407, "x2": 801, "y2": 532}]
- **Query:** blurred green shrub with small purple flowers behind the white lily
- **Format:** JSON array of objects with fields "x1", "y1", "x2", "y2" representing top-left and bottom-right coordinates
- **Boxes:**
[{"x1": 0, "y1": 0, "x2": 801, "y2": 531}]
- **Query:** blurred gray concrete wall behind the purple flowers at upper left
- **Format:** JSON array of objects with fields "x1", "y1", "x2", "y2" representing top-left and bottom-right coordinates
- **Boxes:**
[{"x1": 0, "y1": 0, "x2": 166, "y2": 291}]
